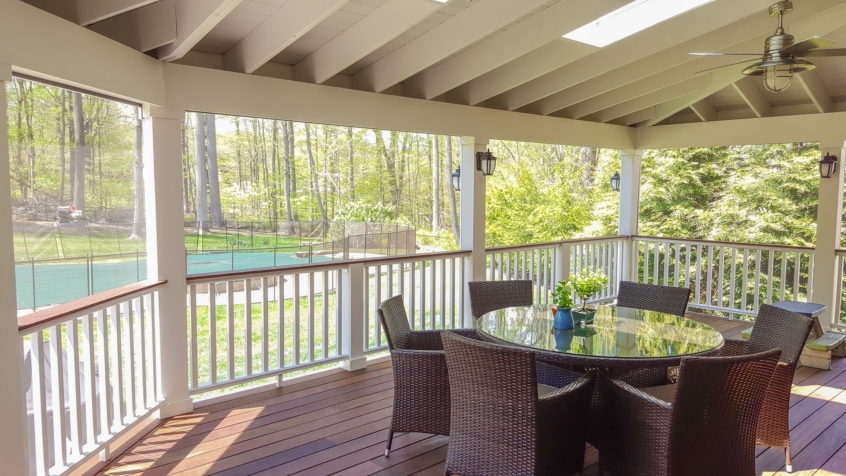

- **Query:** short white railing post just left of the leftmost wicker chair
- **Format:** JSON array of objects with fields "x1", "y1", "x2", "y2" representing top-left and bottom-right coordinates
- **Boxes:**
[{"x1": 341, "y1": 263, "x2": 367, "y2": 370}]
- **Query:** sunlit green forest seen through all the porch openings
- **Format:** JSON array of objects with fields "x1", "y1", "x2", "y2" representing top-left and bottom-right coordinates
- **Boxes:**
[{"x1": 6, "y1": 78, "x2": 818, "y2": 260}]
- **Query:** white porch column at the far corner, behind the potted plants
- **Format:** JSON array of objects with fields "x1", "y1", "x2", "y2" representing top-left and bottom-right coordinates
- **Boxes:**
[{"x1": 617, "y1": 149, "x2": 643, "y2": 281}]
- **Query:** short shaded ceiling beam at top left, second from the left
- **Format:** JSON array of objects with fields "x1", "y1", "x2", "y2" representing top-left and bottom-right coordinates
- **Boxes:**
[{"x1": 89, "y1": 0, "x2": 177, "y2": 51}]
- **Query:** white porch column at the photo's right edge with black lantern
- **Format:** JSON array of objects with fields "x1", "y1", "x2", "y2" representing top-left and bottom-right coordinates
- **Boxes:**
[{"x1": 811, "y1": 140, "x2": 846, "y2": 329}]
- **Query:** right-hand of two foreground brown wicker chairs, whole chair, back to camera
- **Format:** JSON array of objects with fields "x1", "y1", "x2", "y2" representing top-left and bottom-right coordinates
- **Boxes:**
[{"x1": 599, "y1": 350, "x2": 781, "y2": 476}]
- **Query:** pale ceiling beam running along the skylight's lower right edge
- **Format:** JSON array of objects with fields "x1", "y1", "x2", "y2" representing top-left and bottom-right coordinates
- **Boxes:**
[{"x1": 496, "y1": 0, "x2": 780, "y2": 113}]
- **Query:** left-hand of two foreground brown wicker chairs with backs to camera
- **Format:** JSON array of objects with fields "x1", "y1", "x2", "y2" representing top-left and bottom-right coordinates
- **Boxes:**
[{"x1": 443, "y1": 334, "x2": 594, "y2": 476}]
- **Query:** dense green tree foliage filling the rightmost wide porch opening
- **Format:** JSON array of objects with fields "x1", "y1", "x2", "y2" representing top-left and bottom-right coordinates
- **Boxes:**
[{"x1": 640, "y1": 143, "x2": 819, "y2": 246}]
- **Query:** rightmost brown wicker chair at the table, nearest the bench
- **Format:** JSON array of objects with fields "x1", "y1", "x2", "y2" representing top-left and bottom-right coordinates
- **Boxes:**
[{"x1": 720, "y1": 304, "x2": 814, "y2": 472}]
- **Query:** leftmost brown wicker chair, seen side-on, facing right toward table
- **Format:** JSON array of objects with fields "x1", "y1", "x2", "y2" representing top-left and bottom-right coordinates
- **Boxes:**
[{"x1": 378, "y1": 295, "x2": 481, "y2": 456}]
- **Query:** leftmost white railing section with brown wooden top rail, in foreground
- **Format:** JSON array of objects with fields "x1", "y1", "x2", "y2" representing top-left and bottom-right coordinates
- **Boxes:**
[{"x1": 19, "y1": 282, "x2": 165, "y2": 475}]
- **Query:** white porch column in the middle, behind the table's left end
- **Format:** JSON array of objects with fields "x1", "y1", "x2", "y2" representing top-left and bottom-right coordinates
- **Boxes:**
[{"x1": 460, "y1": 137, "x2": 488, "y2": 327}]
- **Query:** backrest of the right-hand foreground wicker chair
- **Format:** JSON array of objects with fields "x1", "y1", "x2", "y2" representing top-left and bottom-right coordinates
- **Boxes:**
[{"x1": 667, "y1": 349, "x2": 781, "y2": 475}]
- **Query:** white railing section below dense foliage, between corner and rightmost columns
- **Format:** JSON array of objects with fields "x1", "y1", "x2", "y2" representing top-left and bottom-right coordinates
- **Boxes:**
[{"x1": 631, "y1": 236, "x2": 814, "y2": 316}]
